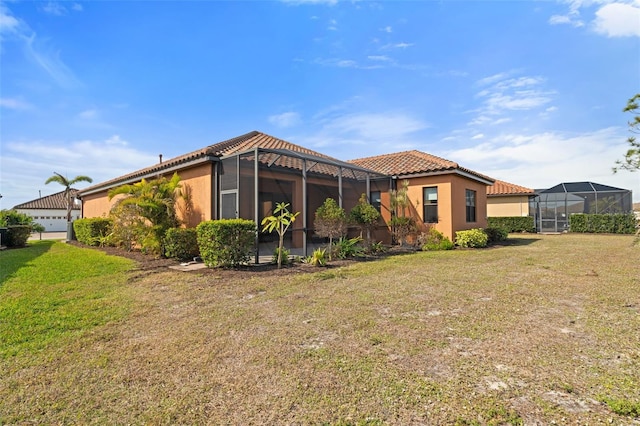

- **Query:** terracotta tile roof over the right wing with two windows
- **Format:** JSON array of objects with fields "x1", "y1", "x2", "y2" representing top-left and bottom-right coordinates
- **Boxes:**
[{"x1": 349, "y1": 150, "x2": 494, "y2": 182}]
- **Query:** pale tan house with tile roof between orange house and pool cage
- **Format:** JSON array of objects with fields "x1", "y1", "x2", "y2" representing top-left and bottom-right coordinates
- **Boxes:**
[{"x1": 487, "y1": 180, "x2": 536, "y2": 217}]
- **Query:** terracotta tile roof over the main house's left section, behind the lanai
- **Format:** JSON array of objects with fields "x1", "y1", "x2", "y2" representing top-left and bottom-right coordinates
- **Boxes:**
[{"x1": 80, "y1": 131, "x2": 374, "y2": 194}]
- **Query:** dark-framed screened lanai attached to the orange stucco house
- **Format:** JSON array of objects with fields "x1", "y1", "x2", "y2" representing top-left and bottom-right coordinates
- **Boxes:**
[{"x1": 216, "y1": 147, "x2": 390, "y2": 262}]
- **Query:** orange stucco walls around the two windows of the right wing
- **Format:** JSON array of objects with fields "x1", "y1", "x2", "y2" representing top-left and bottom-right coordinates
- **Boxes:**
[{"x1": 398, "y1": 174, "x2": 487, "y2": 241}]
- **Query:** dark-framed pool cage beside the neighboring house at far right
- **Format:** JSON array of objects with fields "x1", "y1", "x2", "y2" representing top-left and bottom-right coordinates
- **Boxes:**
[{"x1": 529, "y1": 182, "x2": 633, "y2": 232}]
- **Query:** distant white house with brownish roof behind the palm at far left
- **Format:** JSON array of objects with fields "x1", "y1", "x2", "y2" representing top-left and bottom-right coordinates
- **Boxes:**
[{"x1": 14, "y1": 188, "x2": 81, "y2": 232}]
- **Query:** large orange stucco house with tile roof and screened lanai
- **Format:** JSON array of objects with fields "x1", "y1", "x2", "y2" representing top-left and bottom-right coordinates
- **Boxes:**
[{"x1": 80, "y1": 131, "x2": 493, "y2": 255}]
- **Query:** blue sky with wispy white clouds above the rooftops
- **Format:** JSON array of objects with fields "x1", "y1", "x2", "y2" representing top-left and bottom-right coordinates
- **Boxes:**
[{"x1": 0, "y1": 0, "x2": 640, "y2": 208}]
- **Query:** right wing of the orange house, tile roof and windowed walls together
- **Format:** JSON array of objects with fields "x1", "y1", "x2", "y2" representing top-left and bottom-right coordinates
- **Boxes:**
[{"x1": 350, "y1": 150, "x2": 494, "y2": 241}]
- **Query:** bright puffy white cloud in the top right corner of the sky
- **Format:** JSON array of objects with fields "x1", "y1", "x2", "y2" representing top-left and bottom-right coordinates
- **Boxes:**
[{"x1": 594, "y1": 3, "x2": 640, "y2": 37}]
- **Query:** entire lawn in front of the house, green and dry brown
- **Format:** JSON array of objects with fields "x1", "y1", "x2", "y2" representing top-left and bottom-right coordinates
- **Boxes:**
[{"x1": 0, "y1": 235, "x2": 640, "y2": 425}]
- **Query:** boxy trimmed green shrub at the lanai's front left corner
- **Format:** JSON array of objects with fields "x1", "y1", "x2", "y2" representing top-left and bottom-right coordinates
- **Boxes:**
[{"x1": 196, "y1": 219, "x2": 256, "y2": 268}]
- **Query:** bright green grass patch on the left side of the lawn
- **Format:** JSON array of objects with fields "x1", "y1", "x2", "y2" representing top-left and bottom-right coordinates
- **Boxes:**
[{"x1": 0, "y1": 241, "x2": 132, "y2": 362}]
